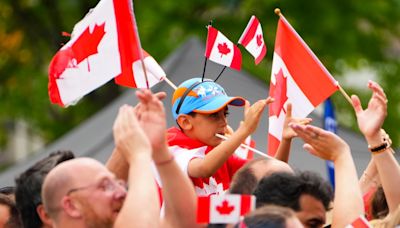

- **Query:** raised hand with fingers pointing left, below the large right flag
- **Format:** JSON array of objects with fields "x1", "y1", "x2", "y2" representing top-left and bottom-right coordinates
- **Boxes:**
[{"x1": 289, "y1": 124, "x2": 350, "y2": 162}]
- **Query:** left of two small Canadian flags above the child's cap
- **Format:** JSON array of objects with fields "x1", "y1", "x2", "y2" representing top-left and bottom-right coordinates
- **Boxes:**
[{"x1": 205, "y1": 25, "x2": 242, "y2": 70}]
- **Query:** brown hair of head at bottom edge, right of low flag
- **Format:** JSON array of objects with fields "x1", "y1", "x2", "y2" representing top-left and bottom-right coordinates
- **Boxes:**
[{"x1": 239, "y1": 205, "x2": 296, "y2": 228}]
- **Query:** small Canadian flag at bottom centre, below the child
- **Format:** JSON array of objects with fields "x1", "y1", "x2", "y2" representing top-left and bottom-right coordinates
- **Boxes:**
[{"x1": 197, "y1": 194, "x2": 256, "y2": 224}]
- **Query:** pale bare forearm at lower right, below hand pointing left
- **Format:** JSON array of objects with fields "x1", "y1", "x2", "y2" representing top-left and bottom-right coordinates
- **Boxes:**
[{"x1": 332, "y1": 150, "x2": 364, "y2": 227}]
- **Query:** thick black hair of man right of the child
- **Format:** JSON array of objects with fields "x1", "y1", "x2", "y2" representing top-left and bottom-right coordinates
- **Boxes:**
[{"x1": 254, "y1": 171, "x2": 333, "y2": 211}]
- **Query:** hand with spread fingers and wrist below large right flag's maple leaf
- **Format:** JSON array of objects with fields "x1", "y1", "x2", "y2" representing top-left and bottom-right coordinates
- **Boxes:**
[{"x1": 275, "y1": 103, "x2": 312, "y2": 163}]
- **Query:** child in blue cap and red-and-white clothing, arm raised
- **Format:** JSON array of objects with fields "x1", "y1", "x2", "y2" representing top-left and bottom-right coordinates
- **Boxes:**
[{"x1": 168, "y1": 78, "x2": 273, "y2": 195}]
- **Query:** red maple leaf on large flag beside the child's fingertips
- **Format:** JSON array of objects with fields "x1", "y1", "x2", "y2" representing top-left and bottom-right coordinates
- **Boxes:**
[{"x1": 270, "y1": 69, "x2": 288, "y2": 117}]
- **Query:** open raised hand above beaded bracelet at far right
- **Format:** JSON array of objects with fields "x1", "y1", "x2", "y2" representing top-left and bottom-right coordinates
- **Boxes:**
[{"x1": 351, "y1": 81, "x2": 387, "y2": 140}]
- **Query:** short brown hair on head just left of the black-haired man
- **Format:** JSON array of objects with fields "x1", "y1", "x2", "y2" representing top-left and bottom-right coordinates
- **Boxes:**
[{"x1": 229, "y1": 158, "x2": 265, "y2": 194}]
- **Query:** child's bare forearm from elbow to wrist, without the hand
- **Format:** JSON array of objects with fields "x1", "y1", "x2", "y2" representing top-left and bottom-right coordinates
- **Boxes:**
[{"x1": 188, "y1": 127, "x2": 249, "y2": 178}]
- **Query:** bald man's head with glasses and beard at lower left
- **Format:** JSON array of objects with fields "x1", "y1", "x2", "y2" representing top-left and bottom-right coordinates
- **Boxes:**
[{"x1": 42, "y1": 158, "x2": 126, "y2": 227}]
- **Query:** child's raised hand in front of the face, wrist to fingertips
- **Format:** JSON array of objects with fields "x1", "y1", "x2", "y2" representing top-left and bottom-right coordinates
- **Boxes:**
[{"x1": 239, "y1": 97, "x2": 274, "y2": 135}]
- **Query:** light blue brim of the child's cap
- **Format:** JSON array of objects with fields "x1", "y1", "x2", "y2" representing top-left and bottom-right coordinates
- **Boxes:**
[{"x1": 193, "y1": 96, "x2": 246, "y2": 114}]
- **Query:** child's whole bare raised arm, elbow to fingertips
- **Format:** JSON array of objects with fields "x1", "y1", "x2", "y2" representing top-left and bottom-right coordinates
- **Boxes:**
[{"x1": 188, "y1": 97, "x2": 273, "y2": 177}]
